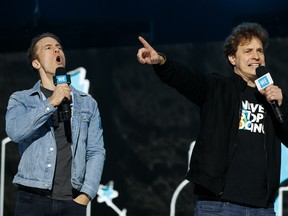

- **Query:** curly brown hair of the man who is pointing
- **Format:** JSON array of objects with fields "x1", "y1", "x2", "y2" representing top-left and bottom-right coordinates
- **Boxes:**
[{"x1": 224, "y1": 22, "x2": 269, "y2": 57}]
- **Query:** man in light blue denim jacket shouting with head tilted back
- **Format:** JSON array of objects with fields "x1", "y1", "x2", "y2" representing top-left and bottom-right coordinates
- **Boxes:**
[{"x1": 6, "y1": 33, "x2": 105, "y2": 216}]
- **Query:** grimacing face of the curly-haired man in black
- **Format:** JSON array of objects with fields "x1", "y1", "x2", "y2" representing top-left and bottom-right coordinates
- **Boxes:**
[{"x1": 228, "y1": 38, "x2": 265, "y2": 86}]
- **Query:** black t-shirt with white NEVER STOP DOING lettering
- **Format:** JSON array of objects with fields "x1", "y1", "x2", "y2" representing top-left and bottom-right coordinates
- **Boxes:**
[{"x1": 221, "y1": 87, "x2": 267, "y2": 207}]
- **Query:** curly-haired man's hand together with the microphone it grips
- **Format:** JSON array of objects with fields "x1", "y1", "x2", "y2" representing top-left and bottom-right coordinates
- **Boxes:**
[{"x1": 255, "y1": 66, "x2": 284, "y2": 123}]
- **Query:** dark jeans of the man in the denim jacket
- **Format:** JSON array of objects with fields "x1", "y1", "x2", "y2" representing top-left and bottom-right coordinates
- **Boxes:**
[{"x1": 15, "y1": 190, "x2": 86, "y2": 216}]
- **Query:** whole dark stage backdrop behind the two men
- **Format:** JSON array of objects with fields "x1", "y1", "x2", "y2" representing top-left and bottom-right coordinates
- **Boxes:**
[{"x1": 0, "y1": 0, "x2": 288, "y2": 216}]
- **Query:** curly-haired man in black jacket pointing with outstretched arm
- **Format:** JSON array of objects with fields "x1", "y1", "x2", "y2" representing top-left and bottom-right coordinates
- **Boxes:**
[{"x1": 137, "y1": 23, "x2": 288, "y2": 216}]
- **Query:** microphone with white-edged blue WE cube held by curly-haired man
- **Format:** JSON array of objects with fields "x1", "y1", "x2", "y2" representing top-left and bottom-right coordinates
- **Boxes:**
[{"x1": 255, "y1": 66, "x2": 284, "y2": 123}]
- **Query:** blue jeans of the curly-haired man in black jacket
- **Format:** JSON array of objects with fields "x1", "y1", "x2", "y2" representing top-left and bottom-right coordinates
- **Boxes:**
[{"x1": 194, "y1": 200, "x2": 276, "y2": 216}]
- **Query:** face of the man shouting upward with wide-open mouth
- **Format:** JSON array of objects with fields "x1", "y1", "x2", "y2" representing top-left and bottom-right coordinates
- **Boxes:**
[{"x1": 32, "y1": 37, "x2": 66, "y2": 76}]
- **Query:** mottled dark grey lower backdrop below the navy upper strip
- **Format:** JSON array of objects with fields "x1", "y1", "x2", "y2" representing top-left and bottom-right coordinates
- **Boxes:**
[{"x1": 0, "y1": 38, "x2": 288, "y2": 216}]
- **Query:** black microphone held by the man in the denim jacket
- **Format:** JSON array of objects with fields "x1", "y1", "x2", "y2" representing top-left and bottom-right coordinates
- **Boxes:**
[{"x1": 53, "y1": 67, "x2": 71, "y2": 122}]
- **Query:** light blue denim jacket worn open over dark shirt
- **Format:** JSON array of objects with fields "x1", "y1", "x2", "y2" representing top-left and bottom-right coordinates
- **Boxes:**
[{"x1": 6, "y1": 81, "x2": 105, "y2": 199}]
